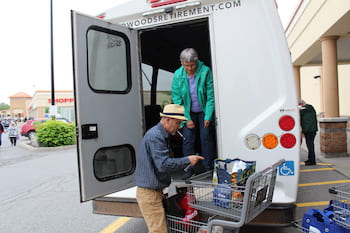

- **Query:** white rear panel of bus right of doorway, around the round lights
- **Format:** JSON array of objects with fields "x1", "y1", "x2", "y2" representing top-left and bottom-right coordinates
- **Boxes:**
[{"x1": 210, "y1": 0, "x2": 300, "y2": 203}]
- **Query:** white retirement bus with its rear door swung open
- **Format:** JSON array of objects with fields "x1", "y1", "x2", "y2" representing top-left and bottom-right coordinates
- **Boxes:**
[{"x1": 72, "y1": 0, "x2": 300, "y2": 225}]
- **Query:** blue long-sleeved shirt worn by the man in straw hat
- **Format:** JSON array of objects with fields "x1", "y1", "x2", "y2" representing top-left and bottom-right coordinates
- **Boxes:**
[{"x1": 135, "y1": 123, "x2": 190, "y2": 189}]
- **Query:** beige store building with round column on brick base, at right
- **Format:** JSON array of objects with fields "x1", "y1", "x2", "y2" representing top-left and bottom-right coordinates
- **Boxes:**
[{"x1": 286, "y1": 0, "x2": 350, "y2": 156}]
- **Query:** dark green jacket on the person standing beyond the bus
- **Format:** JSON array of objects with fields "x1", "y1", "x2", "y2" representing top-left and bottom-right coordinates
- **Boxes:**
[{"x1": 300, "y1": 104, "x2": 318, "y2": 133}]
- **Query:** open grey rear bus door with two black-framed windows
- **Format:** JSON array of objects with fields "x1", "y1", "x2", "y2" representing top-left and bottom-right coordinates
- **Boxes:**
[{"x1": 72, "y1": 11, "x2": 143, "y2": 201}]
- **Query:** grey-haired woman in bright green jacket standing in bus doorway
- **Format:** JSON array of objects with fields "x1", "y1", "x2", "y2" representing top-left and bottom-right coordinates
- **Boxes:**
[{"x1": 172, "y1": 48, "x2": 215, "y2": 170}]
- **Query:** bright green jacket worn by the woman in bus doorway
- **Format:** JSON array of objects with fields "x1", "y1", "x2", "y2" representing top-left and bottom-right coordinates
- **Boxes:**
[{"x1": 172, "y1": 60, "x2": 215, "y2": 121}]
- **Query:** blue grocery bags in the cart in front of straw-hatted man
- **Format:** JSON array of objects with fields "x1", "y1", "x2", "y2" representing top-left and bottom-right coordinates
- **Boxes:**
[{"x1": 213, "y1": 159, "x2": 256, "y2": 208}]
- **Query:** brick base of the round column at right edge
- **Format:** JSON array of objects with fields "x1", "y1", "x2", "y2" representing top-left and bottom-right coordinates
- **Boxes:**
[{"x1": 319, "y1": 117, "x2": 349, "y2": 157}]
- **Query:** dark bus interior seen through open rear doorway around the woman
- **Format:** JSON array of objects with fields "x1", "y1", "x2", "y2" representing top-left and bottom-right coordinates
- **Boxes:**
[{"x1": 140, "y1": 18, "x2": 215, "y2": 164}]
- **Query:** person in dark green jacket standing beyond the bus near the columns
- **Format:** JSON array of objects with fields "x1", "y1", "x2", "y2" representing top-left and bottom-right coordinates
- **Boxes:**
[{"x1": 299, "y1": 100, "x2": 318, "y2": 166}]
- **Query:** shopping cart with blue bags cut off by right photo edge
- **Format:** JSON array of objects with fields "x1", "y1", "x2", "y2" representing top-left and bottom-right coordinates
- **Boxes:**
[{"x1": 329, "y1": 184, "x2": 350, "y2": 229}]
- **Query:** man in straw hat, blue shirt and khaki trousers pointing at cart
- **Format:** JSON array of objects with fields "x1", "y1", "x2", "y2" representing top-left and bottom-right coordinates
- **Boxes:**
[{"x1": 135, "y1": 104, "x2": 204, "y2": 233}]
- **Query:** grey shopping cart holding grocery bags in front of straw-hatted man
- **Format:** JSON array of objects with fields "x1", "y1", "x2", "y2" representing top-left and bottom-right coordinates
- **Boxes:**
[{"x1": 167, "y1": 159, "x2": 285, "y2": 233}]
